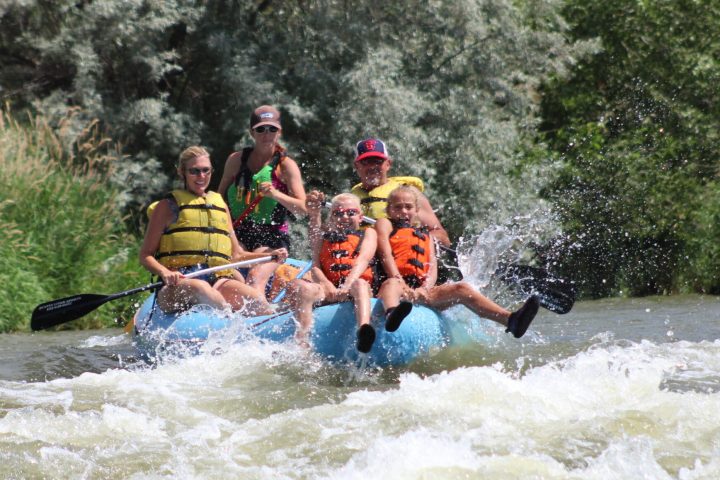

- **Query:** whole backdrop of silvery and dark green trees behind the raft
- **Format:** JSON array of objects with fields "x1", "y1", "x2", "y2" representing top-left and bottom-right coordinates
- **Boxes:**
[{"x1": 0, "y1": 0, "x2": 720, "y2": 330}]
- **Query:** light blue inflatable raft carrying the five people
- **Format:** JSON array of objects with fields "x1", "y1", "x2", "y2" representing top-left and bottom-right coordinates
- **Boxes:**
[{"x1": 134, "y1": 295, "x2": 496, "y2": 367}]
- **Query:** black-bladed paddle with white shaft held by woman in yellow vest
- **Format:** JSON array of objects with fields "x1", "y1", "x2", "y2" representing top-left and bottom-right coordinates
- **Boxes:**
[{"x1": 30, "y1": 255, "x2": 273, "y2": 330}]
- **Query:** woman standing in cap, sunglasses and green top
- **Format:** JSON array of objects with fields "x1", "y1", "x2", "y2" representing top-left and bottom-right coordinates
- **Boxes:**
[{"x1": 218, "y1": 105, "x2": 307, "y2": 290}]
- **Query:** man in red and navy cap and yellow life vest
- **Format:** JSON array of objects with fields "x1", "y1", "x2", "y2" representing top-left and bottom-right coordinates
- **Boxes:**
[{"x1": 351, "y1": 138, "x2": 450, "y2": 246}]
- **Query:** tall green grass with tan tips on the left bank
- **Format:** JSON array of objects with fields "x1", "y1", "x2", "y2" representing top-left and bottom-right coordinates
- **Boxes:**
[{"x1": 0, "y1": 111, "x2": 149, "y2": 332}]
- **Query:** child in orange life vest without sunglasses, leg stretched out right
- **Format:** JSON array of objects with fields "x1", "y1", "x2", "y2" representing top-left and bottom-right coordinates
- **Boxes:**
[{"x1": 375, "y1": 186, "x2": 539, "y2": 338}]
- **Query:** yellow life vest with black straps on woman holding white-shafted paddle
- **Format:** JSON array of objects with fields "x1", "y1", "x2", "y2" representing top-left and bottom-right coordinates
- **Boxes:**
[{"x1": 155, "y1": 190, "x2": 232, "y2": 277}]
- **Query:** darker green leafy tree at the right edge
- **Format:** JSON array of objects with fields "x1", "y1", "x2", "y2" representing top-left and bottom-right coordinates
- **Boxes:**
[{"x1": 543, "y1": 0, "x2": 720, "y2": 296}]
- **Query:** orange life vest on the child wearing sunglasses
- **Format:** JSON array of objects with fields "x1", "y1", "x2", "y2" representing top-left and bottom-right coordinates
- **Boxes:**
[{"x1": 320, "y1": 231, "x2": 373, "y2": 287}]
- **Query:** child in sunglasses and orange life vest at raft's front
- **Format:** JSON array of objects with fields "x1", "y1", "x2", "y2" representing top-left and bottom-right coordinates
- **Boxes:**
[{"x1": 287, "y1": 191, "x2": 377, "y2": 353}]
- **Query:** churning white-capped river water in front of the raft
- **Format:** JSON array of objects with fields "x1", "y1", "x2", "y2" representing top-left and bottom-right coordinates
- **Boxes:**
[{"x1": 0, "y1": 296, "x2": 720, "y2": 480}]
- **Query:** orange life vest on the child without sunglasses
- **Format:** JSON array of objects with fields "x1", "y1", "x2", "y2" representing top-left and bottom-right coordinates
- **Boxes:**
[{"x1": 389, "y1": 223, "x2": 433, "y2": 288}]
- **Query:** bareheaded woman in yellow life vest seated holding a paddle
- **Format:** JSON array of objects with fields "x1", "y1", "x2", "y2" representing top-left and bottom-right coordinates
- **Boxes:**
[{"x1": 140, "y1": 146, "x2": 287, "y2": 313}]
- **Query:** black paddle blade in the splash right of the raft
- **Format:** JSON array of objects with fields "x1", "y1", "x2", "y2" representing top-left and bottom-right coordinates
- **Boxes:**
[{"x1": 495, "y1": 264, "x2": 577, "y2": 314}]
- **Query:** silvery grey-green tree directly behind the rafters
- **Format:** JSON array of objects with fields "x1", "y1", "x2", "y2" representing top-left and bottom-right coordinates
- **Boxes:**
[{"x1": 0, "y1": 0, "x2": 592, "y2": 242}]
